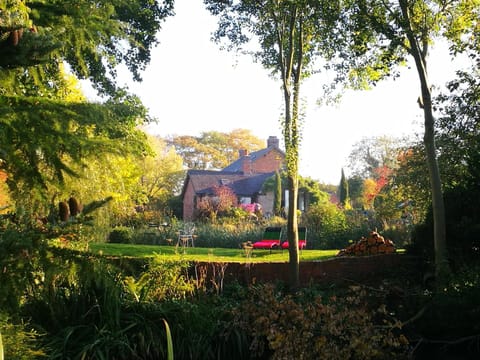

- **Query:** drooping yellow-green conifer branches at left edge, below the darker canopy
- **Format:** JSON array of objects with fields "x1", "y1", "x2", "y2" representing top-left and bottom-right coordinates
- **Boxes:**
[{"x1": 0, "y1": 96, "x2": 149, "y2": 197}]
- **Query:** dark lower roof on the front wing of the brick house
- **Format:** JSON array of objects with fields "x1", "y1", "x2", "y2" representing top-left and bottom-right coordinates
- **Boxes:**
[{"x1": 184, "y1": 170, "x2": 275, "y2": 196}]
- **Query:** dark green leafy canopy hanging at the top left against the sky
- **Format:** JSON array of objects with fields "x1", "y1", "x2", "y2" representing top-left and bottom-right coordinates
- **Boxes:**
[{"x1": 23, "y1": 0, "x2": 173, "y2": 95}]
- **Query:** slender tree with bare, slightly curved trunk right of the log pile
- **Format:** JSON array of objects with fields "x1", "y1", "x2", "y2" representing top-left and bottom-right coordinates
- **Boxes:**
[{"x1": 349, "y1": 0, "x2": 480, "y2": 284}]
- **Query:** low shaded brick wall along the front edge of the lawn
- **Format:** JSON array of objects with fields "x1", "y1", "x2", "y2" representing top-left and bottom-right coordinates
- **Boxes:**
[{"x1": 191, "y1": 254, "x2": 420, "y2": 285}]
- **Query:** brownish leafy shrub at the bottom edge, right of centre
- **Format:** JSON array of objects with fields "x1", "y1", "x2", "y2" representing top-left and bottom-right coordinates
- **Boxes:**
[{"x1": 225, "y1": 285, "x2": 408, "y2": 360}]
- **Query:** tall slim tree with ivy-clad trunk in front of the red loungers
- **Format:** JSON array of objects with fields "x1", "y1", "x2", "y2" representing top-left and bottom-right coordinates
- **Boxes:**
[{"x1": 205, "y1": 0, "x2": 339, "y2": 288}]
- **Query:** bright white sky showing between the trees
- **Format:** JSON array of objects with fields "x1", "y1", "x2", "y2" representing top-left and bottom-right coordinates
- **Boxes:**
[{"x1": 94, "y1": 0, "x2": 468, "y2": 184}]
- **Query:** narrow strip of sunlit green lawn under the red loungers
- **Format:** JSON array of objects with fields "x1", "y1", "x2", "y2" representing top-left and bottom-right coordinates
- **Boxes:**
[{"x1": 89, "y1": 243, "x2": 338, "y2": 262}]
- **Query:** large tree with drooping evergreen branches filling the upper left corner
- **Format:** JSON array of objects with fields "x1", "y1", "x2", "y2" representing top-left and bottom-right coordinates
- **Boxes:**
[{"x1": 0, "y1": 0, "x2": 173, "y2": 205}]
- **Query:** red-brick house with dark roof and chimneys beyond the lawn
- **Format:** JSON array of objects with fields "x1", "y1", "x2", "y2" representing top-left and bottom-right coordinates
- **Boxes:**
[{"x1": 182, "y1": 136, "x2": 285, "y2": 220}]
